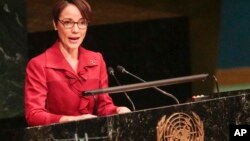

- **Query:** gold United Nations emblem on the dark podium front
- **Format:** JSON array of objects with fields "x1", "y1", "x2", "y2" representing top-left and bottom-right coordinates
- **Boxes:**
[{"x1": 156, "y1": 112, "x2": 204, "y2": 141}]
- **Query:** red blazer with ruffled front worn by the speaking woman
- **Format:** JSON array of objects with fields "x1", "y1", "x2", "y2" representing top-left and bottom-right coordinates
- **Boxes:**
[{"x1": 25, "y1": 42, "x2": 116, "y2": 126}]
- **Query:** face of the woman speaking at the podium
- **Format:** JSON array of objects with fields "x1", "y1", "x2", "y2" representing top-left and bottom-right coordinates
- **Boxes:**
[{"x1": 54, "y1": 4, "x2": 87, "y2": 50}]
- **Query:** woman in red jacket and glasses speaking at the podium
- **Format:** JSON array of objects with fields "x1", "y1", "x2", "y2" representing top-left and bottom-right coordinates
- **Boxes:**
[{"x1": 25, "y1": 0, "x2": 130, "y2": 126}]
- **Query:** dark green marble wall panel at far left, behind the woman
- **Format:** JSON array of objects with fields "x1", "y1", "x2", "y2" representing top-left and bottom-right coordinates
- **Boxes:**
[{"x1": 0, "y1": 0, "x2": 27, "y2": 119}]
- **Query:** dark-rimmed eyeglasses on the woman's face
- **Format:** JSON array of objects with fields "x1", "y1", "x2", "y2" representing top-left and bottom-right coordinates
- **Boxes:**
[{"x1": 58, "y1": 19, "x2": 88, "y2": 29}]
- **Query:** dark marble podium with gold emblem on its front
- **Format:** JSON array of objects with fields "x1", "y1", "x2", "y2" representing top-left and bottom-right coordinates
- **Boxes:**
[{"x1": 1, "y1": 90, "x2": 250, "y2": 141}]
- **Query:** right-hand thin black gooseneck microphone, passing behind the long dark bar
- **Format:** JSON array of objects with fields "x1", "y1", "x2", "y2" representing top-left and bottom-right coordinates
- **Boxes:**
[{"x1": 116, "y1": 65, "x2": 180, "y2": 104}]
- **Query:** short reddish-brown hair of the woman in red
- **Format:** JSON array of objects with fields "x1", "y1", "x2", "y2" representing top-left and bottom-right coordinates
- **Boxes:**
[{"x1": 52, "y1": 0, "x2": 92, "y2": 22}]
